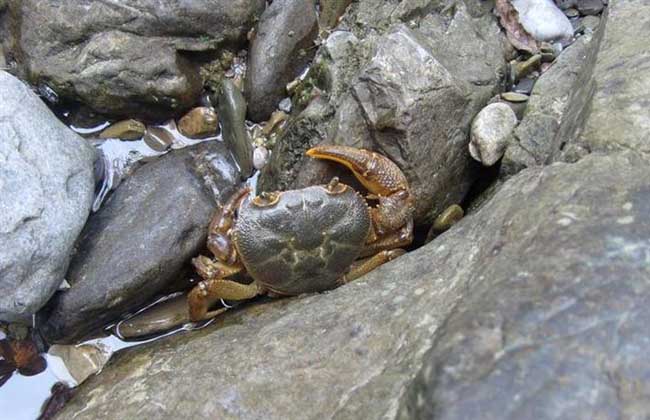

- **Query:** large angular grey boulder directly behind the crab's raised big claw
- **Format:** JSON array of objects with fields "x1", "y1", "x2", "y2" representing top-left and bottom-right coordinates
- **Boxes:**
[{"x1": 260, "y1": 0, "x2": 505, "y2": 222}]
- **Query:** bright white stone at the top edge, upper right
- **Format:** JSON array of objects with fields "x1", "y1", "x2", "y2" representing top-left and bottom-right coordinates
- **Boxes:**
[{"x1": 512, "y1": 0, "x2": 573, "y2": 41}]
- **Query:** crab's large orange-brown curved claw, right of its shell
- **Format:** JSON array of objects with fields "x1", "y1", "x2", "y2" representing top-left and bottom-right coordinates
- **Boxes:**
[{"x1": 307, "y1": 145, "x2": 414, "y2": 237}]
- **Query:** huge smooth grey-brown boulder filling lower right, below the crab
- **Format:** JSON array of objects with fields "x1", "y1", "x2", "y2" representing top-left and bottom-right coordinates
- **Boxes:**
[{"x1": 55, "y1": 149, "x2": 650, "y2": 419}]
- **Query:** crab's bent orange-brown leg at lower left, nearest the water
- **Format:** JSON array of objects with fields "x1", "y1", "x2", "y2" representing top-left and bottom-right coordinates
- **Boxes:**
[{"x1": 187, "y1": 279, "x2": 263, "y2": 322}]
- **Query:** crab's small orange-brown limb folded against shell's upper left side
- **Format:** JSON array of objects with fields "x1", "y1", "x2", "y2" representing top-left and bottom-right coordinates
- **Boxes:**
[{"x1": 208, "y1": 187, "x2": 250, "y2": 265}]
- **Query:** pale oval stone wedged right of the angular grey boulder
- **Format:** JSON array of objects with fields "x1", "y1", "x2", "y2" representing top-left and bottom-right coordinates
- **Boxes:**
[{"x1": 469, "y1": 102, "x2": 517, "y2": 166}]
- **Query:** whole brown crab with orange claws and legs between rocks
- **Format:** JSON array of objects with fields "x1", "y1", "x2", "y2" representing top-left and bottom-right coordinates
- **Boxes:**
[{"x1": 188, "y1": 146, "x2": 414, "y2": 321}]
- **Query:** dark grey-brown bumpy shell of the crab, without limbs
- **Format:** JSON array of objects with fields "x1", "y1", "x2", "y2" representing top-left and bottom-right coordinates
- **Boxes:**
[{"x1": 232, "y1": 184, "x2": 371, "y2": 295}]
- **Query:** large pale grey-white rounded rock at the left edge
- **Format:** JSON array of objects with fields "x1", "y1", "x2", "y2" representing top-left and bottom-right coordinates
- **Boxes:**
[{"x1": 0, "y1": 71, "x2": 95, "y2": 324}]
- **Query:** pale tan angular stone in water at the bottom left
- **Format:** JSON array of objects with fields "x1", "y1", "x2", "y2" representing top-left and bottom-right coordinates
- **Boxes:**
[{"x1": 47, "y1": 343, "x2": 112, "y2": 385}]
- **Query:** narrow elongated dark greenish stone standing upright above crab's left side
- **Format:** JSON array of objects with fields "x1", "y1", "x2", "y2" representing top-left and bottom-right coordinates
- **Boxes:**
[{"x1": 218, "y1": 80, "x2": 253, "y2": 178}]
